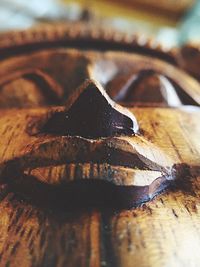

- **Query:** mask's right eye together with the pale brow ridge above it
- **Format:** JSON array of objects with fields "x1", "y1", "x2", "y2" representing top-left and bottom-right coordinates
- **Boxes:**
[{"x1": 90, "y1": 56, "x2": 200, "y2": 107}]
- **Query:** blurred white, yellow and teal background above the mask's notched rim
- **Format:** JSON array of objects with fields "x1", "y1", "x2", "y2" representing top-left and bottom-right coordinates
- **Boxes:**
[{"x1": 0, "y1": 0, "x2": 200, "y2": 48}]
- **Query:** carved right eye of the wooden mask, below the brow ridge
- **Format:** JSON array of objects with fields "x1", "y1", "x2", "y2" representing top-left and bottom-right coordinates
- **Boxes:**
[{"x1": 106, "y1": 70, "x2": 198, "y2": 107}]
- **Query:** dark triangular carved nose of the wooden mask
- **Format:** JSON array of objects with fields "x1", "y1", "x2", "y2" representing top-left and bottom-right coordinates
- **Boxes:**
[{"x1": 42, "y1": 80, "x2": 138, "y2": 139}]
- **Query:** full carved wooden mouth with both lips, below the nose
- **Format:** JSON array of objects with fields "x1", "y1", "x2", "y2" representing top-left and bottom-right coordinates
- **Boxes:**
[{"x1": 1, "y1": 135, "x2": 175, "y2": 208}]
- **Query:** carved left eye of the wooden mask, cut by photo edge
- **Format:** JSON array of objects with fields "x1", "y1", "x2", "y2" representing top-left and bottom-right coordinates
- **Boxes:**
[{"x1": 0, "y1": 69, "x2": 63, "y2": 108}]
